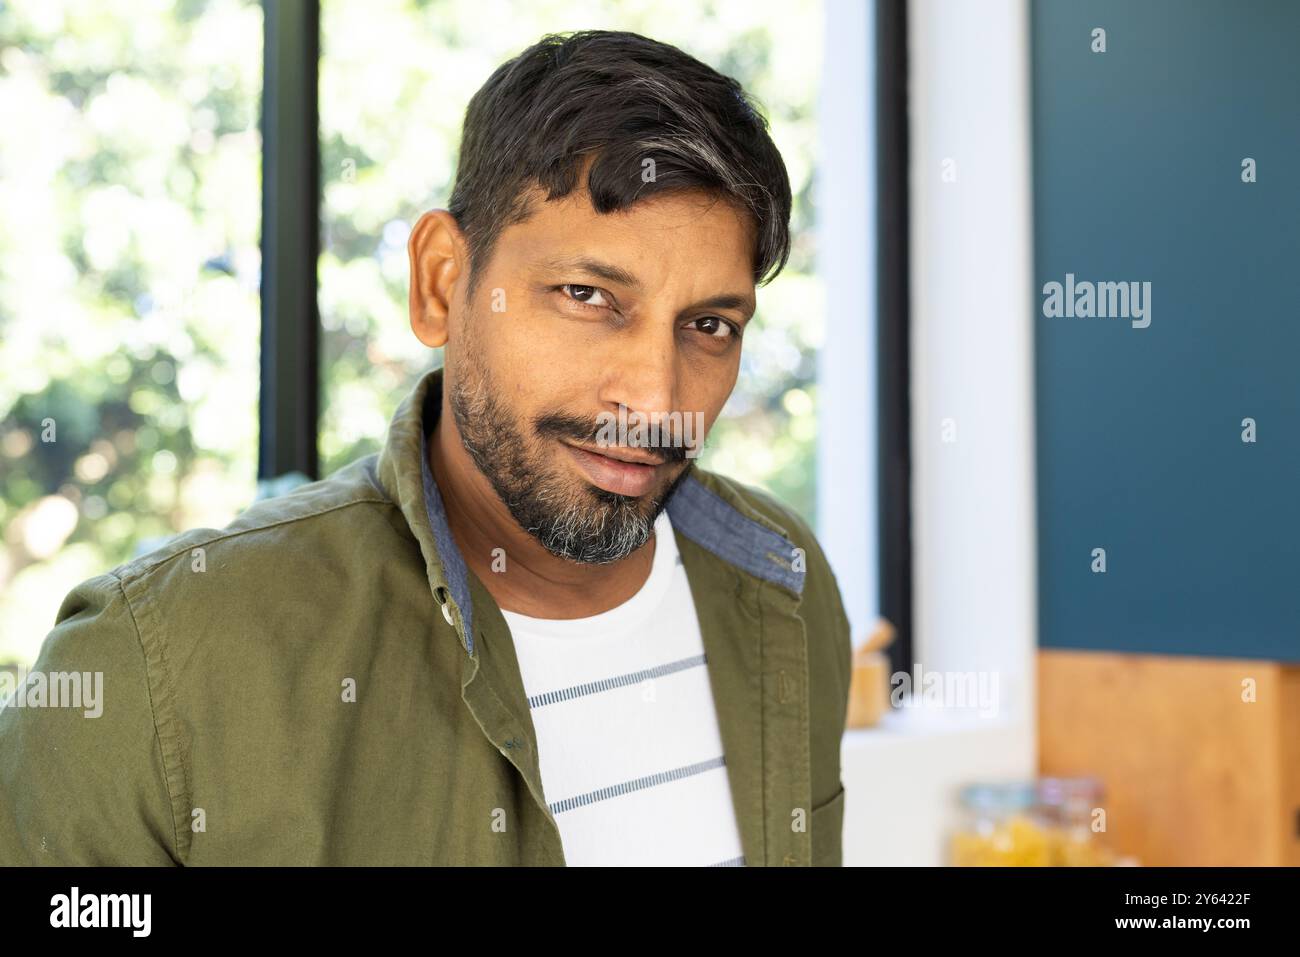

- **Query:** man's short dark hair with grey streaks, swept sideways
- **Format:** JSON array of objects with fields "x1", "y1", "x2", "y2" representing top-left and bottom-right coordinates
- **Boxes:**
[{"x1": 449, "y1": 30, "x2": 790, "y2": 291}]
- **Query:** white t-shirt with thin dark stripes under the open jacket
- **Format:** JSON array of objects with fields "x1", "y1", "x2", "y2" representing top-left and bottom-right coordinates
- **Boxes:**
[{"x1": 503, "y1": 511, "x2": 745, "y2": 866}]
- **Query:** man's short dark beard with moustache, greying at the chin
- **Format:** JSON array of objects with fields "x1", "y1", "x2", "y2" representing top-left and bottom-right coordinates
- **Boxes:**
[{"x1": 449, "y1": 343, "x2": 694, "y2": 564}]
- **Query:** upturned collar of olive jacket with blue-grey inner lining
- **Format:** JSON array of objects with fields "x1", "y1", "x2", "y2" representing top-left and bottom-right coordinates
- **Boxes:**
[{"x1": 378, "y1": 368, "x2": 803, "y2": 655}]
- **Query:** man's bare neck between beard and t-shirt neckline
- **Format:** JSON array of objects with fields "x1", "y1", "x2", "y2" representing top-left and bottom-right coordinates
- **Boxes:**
[{"x1": 429, "y1": 395, "x2": 655, "y2": 619}]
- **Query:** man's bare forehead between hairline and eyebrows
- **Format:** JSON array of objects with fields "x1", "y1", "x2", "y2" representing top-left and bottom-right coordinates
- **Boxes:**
[{"x1": 499, "y1": 186, "x2": 755, "y2": 289}]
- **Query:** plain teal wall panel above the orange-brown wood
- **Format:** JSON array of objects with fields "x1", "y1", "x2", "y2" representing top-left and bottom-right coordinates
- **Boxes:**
[{"x1": 1032, "y1": 0, "x2": 1300, "y2": 661}]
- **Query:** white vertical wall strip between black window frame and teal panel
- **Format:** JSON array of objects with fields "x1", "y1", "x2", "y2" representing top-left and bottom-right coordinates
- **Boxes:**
[{"x1": 910, "y1": 0, "x2": 1037, "y2": 716}]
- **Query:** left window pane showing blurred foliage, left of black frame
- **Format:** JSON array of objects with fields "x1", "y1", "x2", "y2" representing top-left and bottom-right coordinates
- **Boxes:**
[{"x1": 0, "y1": 0, "x2": 263, "y2": 663}]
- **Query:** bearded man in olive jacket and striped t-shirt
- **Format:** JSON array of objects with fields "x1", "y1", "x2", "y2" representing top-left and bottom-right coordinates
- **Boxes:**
[{"x1": 0, "y1": 33, "x2": 849, "y2": 865}]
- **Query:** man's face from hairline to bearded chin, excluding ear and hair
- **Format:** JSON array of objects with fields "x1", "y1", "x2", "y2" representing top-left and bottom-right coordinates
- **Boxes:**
[{"x1": 446, "y1": 189, "x2": 754, "y2": 563}]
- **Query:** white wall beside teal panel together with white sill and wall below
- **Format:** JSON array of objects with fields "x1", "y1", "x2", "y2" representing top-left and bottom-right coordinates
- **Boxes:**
[{"x1": 828, "y1": 0, "x2": 1037, "y2": 865}]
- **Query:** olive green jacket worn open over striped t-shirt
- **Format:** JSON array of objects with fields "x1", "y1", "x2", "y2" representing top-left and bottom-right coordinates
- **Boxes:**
[{"x1": 0, "y1": 371, "x2": 850, "y2": 866}]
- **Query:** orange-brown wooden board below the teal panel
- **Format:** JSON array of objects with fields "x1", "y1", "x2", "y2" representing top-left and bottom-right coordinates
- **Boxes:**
[{"x1": 1037, "y1": 649, "x2": 1300, "y2": 866}]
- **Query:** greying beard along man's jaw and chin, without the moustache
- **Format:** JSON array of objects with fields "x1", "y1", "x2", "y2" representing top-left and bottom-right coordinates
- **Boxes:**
[{"x1": 450, "y1": 360, "x2": 670, "y2": 564}]
